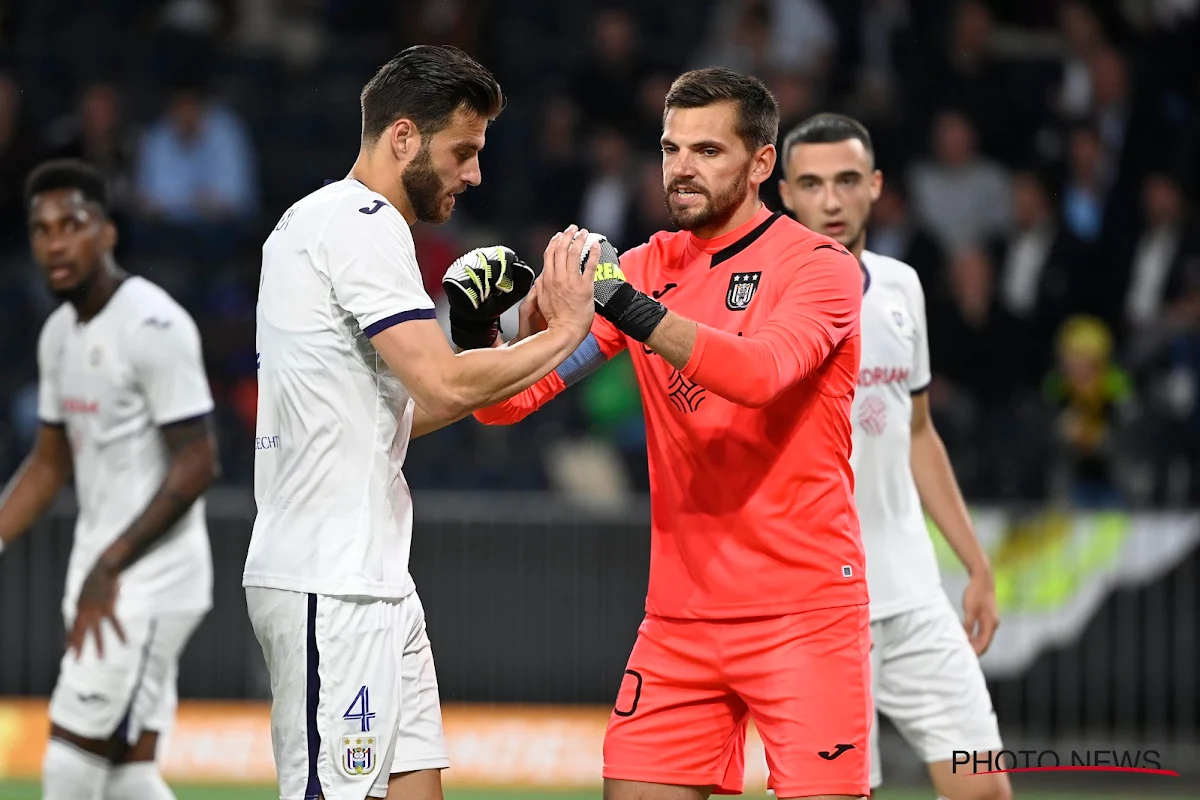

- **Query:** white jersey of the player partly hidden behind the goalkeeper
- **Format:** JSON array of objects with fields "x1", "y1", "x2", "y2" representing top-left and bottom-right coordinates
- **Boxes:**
[{"x1": 851, "y1": 251, "x2": 944, "y2": 620}]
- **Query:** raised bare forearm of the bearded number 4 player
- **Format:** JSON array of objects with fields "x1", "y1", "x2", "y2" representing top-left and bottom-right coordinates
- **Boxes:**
[{"x1": 448, "y1": 327, "x2": 580, "y2": 419}]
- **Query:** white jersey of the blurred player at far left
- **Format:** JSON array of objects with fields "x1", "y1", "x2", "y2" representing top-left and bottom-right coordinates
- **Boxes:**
[{"x1": 37, "y1": 277, "x2": 212, "y2": 619}]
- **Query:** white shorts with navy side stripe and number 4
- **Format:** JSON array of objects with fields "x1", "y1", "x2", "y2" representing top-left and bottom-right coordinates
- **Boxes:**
[{"x1": 246, "y1": 587, "x2": 450, "y2": 800}]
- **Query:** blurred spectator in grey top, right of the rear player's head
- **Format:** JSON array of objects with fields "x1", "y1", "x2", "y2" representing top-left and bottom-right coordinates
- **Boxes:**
[{"x1": 908, "y1": 110, "x2": 1012, "y2": 252}]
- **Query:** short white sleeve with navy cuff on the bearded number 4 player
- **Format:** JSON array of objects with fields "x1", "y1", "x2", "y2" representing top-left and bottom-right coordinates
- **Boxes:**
[{"x1": 324, "y1": 199, "x2": 437, "y2": 337}]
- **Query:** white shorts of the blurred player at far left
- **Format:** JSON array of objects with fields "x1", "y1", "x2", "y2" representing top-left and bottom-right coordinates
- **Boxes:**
[{"x1": 50, "y1": 612, "x2": 205, "y2": 745}]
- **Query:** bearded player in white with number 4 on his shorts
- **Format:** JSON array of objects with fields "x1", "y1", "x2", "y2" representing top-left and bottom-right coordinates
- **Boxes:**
[{"x1": 244, "y1": 46, "x2": 599, "y2": 800}]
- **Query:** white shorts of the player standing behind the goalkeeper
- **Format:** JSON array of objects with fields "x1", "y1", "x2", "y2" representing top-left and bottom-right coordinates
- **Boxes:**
[{"x1": 871, "y1": 599, "x2": 1002, "y2": 789}]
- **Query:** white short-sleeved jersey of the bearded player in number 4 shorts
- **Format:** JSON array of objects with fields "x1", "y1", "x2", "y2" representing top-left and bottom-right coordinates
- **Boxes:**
[{"x1": 242, "y1": 179, "x2": 436, "y2": 599}]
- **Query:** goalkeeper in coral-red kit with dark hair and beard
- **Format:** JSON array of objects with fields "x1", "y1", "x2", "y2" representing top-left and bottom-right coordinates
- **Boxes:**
[{"x1": 475, "y1": 68, "x2": 871, "y2": 800}]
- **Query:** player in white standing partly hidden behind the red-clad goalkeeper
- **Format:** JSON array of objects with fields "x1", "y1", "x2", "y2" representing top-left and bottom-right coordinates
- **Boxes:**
[{"x1": 779, "y1": 114, "x2": 1012, "y2": 800}]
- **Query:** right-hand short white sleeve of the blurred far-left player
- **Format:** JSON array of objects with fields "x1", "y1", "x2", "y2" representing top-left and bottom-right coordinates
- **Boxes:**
[{"x1": 131, "y1": 307, "x2": 212, "y2": 427}]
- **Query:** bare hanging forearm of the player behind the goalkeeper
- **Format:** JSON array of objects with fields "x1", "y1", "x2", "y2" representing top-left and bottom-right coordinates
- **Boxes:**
[{"x1": 911, "y1": 423, "x2": 991, "y2": 577}]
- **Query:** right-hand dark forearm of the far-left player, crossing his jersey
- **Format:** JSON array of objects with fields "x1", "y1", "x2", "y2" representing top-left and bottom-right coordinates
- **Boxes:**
[{"x1": 100, "y1": 420, "x2": 218, "y2": 572}]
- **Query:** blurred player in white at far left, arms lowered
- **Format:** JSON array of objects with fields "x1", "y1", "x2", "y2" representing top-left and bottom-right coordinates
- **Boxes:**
[{"x1": 0, "y1": 161, "x2": 217, "y2": 800}]
